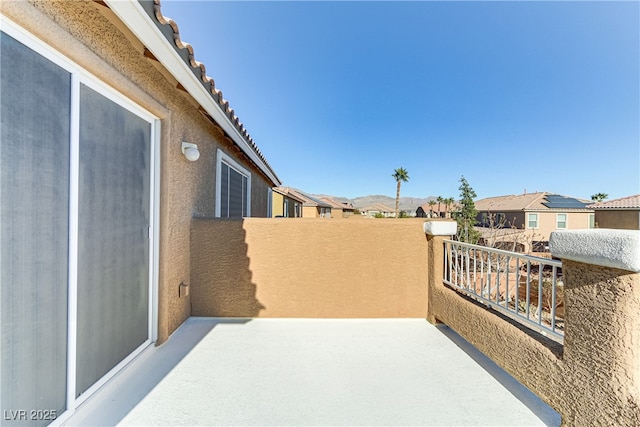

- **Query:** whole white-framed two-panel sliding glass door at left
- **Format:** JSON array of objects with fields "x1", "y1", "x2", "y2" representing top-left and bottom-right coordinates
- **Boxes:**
[{"x1": 0, "y1": 25, "x2": 156, "y2": 425}]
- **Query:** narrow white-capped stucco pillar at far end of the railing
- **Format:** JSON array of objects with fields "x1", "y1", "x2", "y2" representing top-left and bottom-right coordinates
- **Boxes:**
[{"x1": 424, "y1": 220, "x2": 458, "y2": 324}]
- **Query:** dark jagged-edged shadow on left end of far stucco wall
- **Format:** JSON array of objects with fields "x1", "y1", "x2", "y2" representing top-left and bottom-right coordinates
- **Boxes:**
[{"x1": 191, "y1": 219, "x2": 265, "y2": 317}]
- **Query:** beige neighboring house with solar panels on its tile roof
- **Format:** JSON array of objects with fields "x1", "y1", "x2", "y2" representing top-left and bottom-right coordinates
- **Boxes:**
[{"x1": 475, "y1": 192, "x2": 594, "y2": 252}]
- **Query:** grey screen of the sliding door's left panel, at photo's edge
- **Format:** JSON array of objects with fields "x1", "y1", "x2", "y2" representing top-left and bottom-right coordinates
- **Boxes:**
[{"x1": 0, "y1": 33, "x2": 71, "y2": 425}]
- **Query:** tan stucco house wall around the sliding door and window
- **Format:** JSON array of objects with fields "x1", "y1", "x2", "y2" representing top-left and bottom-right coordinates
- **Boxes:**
[{"x1": 0, "y1": 0, "x2": 269, "y2": 342}]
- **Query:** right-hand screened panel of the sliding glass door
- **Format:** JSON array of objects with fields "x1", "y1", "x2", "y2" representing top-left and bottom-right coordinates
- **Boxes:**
[{"x1": 76, "y1": 85, "x2": 151, "y2": 397}]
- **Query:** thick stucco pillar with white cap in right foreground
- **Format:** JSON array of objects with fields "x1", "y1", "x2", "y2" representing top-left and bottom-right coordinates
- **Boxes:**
[{"x1": 550, "y1": 229, "x2": 640, "y2": 426}]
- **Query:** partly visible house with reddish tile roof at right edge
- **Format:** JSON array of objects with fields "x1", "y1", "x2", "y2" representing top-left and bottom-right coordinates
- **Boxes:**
[{"x1": 588, "y1": 194, "x2": 640, "y2": 230}]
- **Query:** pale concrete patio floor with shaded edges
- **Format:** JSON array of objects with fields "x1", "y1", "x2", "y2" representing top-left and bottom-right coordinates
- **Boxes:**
[{"x1": 65, "y1": 317, "x2": 560, "y2": 426}]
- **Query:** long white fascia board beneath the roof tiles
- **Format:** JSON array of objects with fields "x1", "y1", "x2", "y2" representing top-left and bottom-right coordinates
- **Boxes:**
[{"x1": 105, "y1": 0, "x2": 281, "y2": 185}]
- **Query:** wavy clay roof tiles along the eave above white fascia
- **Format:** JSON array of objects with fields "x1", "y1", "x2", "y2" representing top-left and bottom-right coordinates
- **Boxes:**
[{"x1": 153, "y1": 0, "x2": 277, "y2": 184}]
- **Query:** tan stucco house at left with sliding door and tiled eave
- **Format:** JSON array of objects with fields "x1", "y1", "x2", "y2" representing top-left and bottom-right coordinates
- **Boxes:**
[{"x1": 0, "y1": 0, "x2": 280, "y2": 425}]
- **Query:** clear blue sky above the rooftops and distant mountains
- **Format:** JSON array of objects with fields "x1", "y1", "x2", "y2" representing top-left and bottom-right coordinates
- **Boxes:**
[{"x1": 161, "y1": 0, "x2": 640, "y2": 199}]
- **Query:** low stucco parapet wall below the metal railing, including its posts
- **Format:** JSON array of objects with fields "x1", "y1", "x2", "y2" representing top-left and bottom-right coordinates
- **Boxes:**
[{"x1": 427, "y1": 232, "x2": 640, "y2": 426}]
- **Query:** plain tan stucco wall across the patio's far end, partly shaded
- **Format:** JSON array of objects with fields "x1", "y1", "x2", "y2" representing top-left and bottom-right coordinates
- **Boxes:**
[{"x1": 191, "y1": 218, "x2": 427, "y2": 318}]
